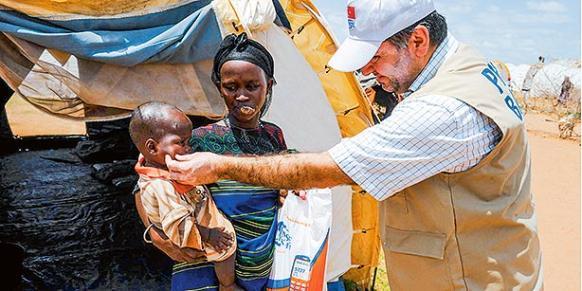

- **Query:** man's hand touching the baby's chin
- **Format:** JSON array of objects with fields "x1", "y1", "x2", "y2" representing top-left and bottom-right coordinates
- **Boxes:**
[{"x1": 166, "y1": 152, "x2": 226, "y2": 185}]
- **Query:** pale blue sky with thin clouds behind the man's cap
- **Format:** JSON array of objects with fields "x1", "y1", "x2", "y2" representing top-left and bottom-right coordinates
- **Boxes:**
[{"x1": 312, "y1": 0, "x2": 582, "y2": 64}]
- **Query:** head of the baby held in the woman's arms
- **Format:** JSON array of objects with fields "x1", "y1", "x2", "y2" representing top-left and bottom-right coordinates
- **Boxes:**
[{"x1": 129, "y1": 101, "x2": 192, "y2": 168}]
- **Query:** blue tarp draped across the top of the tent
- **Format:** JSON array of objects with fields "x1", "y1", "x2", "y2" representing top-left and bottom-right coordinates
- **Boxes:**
[{"x1": 0, "y1": 0, "x2": 221, "y2": 66}]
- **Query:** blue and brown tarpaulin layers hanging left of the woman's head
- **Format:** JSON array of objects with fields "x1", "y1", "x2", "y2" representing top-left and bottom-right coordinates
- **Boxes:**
[{"x1": 0, "y1": 0, "x2": 226, "y2": 120}]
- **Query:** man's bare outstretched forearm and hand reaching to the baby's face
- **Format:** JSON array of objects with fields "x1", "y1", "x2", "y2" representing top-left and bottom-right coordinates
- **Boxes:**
[{"x1": 166, "y1": 152, "x2": 354, "y2": 189}]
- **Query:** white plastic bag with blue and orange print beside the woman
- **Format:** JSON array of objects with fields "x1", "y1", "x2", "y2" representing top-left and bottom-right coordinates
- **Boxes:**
[{"x1": 267, "y1": 189, "x2": 332, "y2": 291}]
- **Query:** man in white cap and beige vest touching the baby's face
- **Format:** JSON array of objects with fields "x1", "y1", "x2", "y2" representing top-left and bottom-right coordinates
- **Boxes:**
[{"x1": 161, "y1": 0, "x2": 543, "y2": 290}]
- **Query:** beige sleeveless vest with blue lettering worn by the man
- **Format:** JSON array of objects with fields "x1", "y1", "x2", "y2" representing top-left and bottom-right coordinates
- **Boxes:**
[{"x1": 380, "y1": 45, "x2": 542, "y2": 290}]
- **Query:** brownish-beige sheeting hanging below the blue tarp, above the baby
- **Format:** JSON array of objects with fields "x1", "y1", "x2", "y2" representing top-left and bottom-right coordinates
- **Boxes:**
[{"x1": 0, "y1": 7, "x2": 226, "y2": 120}]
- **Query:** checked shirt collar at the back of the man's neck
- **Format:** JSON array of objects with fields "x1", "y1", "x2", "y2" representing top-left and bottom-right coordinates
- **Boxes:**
[{"x1": 403, "y1": 33, "x2": 459, "y2": 98}]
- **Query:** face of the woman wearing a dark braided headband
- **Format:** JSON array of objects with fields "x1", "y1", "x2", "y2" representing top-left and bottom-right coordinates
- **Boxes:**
[{"x1": 220, "y1": 61, "x2": 272, "y2": 128}]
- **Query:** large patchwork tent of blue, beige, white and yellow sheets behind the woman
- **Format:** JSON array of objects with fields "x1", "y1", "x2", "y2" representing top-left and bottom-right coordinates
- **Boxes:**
[{"x1": 0, "y1": 0, "x2": 380, "y2": 286}]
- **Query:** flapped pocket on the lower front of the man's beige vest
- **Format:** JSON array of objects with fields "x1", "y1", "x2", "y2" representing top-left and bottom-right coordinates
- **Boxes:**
[{"x1": 384, "y1": 226, "x2": 446, "y2": 260}]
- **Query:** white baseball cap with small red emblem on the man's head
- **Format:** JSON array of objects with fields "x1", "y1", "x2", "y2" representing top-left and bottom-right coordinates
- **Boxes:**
[{"x1": 329, "y1": 0, "x2": 435, "y2": 72}]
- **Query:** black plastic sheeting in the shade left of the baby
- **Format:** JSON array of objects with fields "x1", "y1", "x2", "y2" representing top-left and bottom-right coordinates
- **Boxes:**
[{"x1": 0, "y1": 149, "x2": 171, "y2": 290}]
